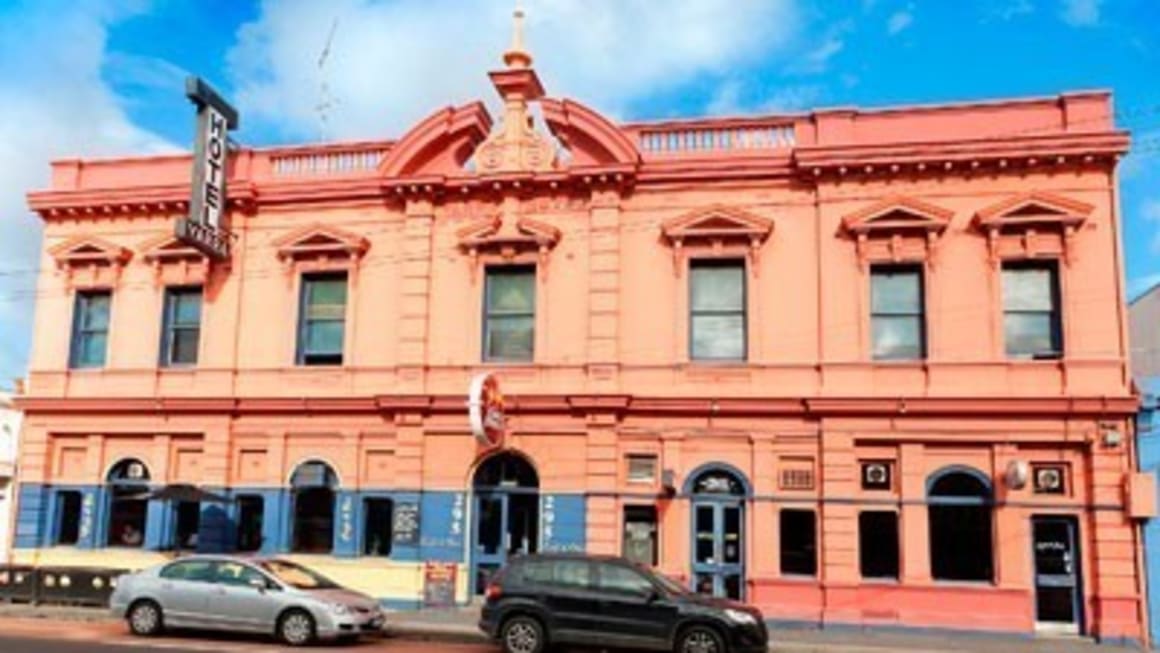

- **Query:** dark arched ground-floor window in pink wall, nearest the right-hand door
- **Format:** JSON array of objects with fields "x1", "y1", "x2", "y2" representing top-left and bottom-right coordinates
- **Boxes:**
[{"x1": 927, "y1": 467, "x2": 993, "y2": 581}]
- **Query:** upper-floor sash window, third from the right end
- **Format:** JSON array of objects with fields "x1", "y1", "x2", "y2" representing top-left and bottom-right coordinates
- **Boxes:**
[{"x1": 689, "y1": 260, "x2": 746, "y2": 361}]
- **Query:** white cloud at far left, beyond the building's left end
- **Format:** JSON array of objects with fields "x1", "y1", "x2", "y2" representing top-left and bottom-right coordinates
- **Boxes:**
[{"x1": 0, "y1": 3, "x2": 171, "y2": 385}]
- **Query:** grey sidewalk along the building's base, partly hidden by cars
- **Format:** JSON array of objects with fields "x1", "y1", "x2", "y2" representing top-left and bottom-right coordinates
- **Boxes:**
[{"x1": 0, "y1": 604, "x2": 1133, "y2": 653}]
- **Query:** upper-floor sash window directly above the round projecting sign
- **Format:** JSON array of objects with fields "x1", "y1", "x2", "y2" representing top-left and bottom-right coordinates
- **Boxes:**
[{"x1": 484, "y1": 266, "x2": 536, "y2": 362}]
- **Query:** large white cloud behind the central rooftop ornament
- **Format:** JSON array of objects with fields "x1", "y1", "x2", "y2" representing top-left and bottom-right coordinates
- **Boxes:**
[{"x1": 229, "y1": 0, "x2": 807, "y2": 139}]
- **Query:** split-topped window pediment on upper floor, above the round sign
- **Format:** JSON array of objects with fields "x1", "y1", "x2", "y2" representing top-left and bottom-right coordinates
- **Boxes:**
[{"x1": 456, "y1": 215, "x2": 563, "y2": 281}]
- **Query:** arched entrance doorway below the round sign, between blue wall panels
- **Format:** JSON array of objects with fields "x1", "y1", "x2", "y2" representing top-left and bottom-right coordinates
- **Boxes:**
[{"x1": 471, "y1": 451, "x2": 539, "y2": 594}]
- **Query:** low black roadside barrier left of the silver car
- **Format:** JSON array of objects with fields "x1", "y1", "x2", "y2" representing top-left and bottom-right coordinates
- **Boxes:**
[{"x1": 0, "y1": 566, "x2": 128, "y2": 607}]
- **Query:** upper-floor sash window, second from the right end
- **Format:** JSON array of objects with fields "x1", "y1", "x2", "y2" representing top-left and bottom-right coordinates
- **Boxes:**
[{"x1": 870, "y1": 266, "x2": 927, "y2": 361}]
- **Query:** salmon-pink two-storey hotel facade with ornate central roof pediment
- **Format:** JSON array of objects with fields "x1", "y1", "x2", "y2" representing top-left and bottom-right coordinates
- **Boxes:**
[{"x1": 6, "y1": 29, "x2": 1153, "y2": 640}]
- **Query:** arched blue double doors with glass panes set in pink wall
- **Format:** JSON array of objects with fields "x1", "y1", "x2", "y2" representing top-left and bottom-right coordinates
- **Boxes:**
[{"x1": 684, "y1": 465, "x2": 751, "y2": 600}]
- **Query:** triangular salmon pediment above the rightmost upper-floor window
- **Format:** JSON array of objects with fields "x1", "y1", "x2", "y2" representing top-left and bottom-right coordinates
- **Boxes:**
[{"x1": 973, "y1": 191, "x2": 1095, "y2": 266}]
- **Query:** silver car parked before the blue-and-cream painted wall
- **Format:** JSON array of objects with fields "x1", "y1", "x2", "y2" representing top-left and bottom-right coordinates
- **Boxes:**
[{"x1": 109, "y1": 556, "x2": 383, "y2": 646}]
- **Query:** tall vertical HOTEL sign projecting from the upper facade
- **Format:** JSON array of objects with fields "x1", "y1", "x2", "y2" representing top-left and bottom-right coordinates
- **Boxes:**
[{"x1": 176, "y1": 77, "x2": 238, "y2": 261}]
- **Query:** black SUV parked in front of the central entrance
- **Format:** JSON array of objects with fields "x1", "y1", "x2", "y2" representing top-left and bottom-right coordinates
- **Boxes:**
[{"x1": 479, "y1": 553, "x2": 767, "y2": 653}]
